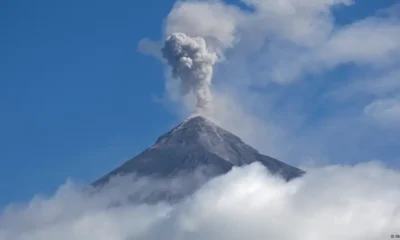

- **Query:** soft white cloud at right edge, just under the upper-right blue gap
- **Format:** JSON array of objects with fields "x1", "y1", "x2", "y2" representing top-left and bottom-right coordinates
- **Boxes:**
[{"x1": 318, "y1": 17, "x2": 400, "y2": 66}]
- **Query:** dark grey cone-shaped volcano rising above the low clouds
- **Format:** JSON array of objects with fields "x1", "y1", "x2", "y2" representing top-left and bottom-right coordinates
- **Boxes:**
[{"x1": 93, "y1": 116, "x2": 304, "y2": 200}]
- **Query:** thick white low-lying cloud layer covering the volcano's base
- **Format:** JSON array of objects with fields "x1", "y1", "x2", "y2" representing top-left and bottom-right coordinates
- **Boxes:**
[{"x1": 0, "y1": 163, "x2": 400, "y2": 240}]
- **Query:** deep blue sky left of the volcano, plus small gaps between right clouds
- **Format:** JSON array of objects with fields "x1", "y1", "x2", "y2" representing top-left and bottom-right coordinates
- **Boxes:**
[{"x1": 0, "y1": 0, "x2": 399, "y2": 207}]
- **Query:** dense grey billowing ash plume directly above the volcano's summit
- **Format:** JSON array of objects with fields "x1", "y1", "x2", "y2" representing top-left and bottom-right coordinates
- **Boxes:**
[{"x1": 162, "y1": 33, "x2": 218, "y2": 109}]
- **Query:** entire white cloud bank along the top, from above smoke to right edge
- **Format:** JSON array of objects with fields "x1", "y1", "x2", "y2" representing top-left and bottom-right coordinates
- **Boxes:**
[{"x1": 161, "y1": 0, "x2": 400, "y2": 84}]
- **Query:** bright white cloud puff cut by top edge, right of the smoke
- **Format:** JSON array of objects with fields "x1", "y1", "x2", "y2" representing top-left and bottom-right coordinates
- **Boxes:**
[{"x1": 239, "y1": 0, "x2": 352, "y2": 47}]
